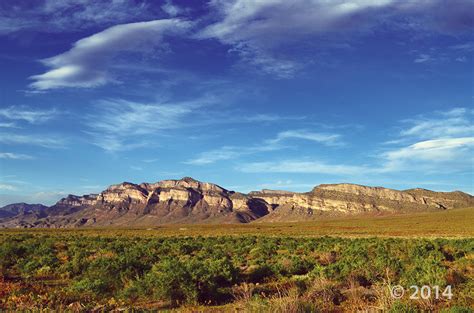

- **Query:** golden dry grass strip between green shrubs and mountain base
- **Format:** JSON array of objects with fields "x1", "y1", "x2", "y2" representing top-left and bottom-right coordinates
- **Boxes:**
[{"x1": 0, "y1": 208, "x2": 474, "y2": 238}]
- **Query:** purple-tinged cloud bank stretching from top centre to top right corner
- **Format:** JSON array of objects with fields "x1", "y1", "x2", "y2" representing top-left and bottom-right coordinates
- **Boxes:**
[{"x1": 197, "y1": 0, "x2": 474, "y2": 78}]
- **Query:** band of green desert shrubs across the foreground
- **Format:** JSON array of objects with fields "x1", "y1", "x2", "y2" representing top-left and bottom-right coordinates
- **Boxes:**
[{"x1": 0, "y1": 231, "x2": 474, "y2": 312}]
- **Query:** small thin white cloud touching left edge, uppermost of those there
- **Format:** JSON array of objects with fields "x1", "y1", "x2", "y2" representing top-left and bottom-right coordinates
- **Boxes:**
[{"x1": 0, "y1": 106, "x2": 59, "y2": 123}]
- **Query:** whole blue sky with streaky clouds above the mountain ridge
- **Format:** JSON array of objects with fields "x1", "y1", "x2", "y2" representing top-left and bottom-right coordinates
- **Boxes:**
[{"x1": 0, "y1": 0, "x2": 474, "y2": 205}]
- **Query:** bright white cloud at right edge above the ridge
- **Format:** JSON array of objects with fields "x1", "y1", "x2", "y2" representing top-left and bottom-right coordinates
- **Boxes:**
[{"x1": 380, "y1": 108, "x2": 474, "y2": 171}]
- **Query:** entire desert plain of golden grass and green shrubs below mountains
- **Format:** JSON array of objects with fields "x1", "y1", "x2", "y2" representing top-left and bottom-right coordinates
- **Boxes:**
[{"x1": 0, "y1": 210, "x2": 474, "y2": 312}]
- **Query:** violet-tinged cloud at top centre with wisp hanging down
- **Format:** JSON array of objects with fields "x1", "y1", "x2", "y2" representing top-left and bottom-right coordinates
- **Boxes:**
[{"x1": 197, "y1": 0, "x2": 396, "y2": 78}]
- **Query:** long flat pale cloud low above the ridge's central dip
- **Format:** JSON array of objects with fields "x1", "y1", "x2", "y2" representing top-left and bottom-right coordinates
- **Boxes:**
[{"x1": 237, "y1": 160, "x2": 369, "y2": 175}]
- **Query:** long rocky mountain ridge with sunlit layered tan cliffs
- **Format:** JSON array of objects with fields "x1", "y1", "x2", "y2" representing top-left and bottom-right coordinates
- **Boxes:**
[{"x1": 0, "y1": 177, "x2": 474, "y2": 227}]
